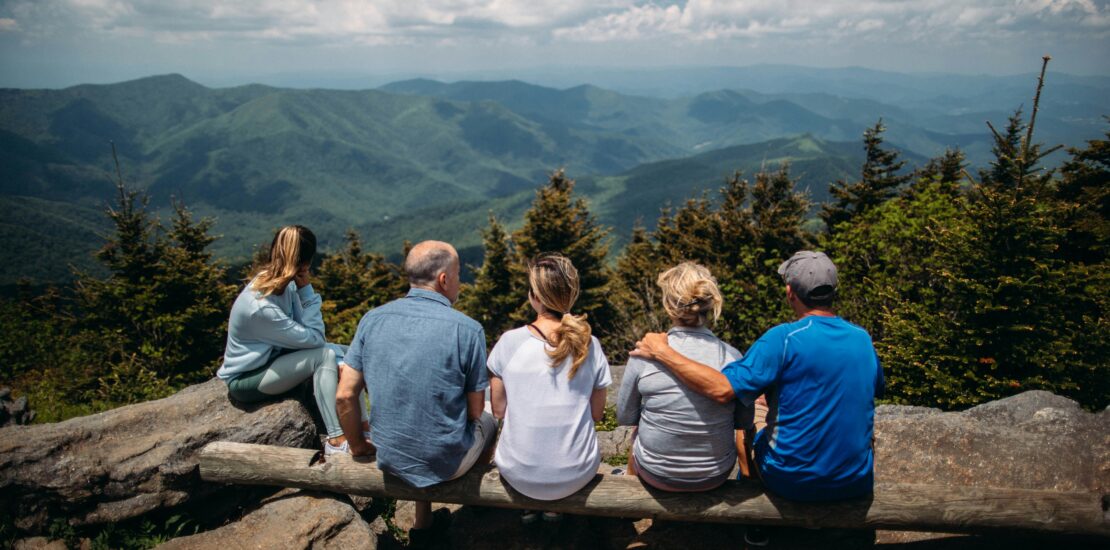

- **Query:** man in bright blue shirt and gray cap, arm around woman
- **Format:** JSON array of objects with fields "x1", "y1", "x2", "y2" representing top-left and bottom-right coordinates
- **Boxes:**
[{"x1": 632, "y1": 251, "x2": 884, "y2": 501}]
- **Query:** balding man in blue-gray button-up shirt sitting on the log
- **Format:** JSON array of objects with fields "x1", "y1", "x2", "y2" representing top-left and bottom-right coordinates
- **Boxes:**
[{"x1": 336, "y1": 241, "x2": 497, "y2": 543}]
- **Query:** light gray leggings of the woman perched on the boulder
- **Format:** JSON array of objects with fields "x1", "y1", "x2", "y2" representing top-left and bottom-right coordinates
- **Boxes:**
[{"x1": 228, "y1": 344, "x2": 369, "y2": 438}]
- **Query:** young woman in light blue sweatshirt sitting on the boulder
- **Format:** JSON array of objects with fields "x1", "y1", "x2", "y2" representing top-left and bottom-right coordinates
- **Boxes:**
[{"x1": 216, "y1": 226, "x2": 369, "y2": 452}]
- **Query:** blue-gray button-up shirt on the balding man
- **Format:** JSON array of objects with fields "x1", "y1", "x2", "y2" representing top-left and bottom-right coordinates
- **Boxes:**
[{"x1": 343, "y1": 289, "x2": 490, "y2": 487}]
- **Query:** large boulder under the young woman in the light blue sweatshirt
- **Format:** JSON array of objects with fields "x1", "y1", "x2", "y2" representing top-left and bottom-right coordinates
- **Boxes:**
[{"x1": 0, "y1": 379, "x2": 316, "y2": 532}]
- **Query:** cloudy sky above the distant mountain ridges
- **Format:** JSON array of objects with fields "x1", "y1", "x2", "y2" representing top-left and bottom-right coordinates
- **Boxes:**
[{"x1": 0, "y1": 0, "x2": 1110, "y2": 87}]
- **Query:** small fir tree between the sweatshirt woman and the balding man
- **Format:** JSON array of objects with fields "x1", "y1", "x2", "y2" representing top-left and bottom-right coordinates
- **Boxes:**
[{"x1": 316, "y1": 229, "x2": 407, "y2": 342}]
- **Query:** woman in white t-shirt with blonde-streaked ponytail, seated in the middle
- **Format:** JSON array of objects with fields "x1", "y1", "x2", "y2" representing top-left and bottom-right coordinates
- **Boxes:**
[{"x1": 488, "y1": 254, "x2": 612, "y2": 521}]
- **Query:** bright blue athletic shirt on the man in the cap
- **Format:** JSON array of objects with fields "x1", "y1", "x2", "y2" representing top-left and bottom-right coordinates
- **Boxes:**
[{"x1": 722, "y1": 316, "x2": 884, "y2": 500}]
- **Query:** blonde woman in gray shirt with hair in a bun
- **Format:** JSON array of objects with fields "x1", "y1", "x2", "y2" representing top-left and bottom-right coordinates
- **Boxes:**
[{"x1": 617, "y1": 262, "x2": 741, "y2": 491}]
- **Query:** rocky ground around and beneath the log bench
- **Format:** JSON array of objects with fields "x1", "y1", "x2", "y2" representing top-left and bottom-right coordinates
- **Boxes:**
[{"x1": 0, "y1": 372, "x2": 1110, "y2": 550}]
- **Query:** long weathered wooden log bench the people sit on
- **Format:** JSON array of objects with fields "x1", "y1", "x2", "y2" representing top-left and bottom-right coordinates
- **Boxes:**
[{"x1": 200, "y1": 441, "x2": 1110, "y2": 537}]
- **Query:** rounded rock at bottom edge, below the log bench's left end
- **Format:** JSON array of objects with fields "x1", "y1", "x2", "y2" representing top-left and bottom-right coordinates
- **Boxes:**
[{"x1": 158, "y1": 491, "x2": 377, "y2": 550}]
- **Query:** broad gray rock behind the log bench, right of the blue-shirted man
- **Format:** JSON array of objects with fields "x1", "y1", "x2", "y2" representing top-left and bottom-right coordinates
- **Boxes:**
[{"x1": 875, "y1": 391, "x2": 1110, "y2": 493}]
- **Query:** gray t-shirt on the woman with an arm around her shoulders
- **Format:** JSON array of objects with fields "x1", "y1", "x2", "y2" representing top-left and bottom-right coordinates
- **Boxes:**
[{"x1": 617, "y1": 327, "x2": 740, "y2": 483}]
